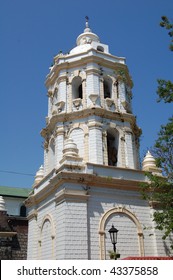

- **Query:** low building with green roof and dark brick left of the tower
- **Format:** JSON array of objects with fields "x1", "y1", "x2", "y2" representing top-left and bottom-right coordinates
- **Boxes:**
[{"x1": 0, "y1": 186, "x2": 30, "y2": 260}]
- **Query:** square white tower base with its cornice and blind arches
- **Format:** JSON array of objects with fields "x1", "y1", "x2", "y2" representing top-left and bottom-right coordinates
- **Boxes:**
[{"x1": 26, "y1": 150, "x2": 171, "y2": 260}]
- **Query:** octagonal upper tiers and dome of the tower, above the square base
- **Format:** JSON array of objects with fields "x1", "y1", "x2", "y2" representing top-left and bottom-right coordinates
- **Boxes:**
[{"x1": 41, "y1": 17, "x2": 141, "y2": 176}]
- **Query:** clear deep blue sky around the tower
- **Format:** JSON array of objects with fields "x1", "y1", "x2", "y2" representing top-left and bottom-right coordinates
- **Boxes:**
[{"x1": 0, "y1": 0, "x2": 173, "y2": 187}]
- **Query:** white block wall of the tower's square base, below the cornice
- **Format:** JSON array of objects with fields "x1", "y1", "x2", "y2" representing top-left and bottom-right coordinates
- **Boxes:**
[{"x1": 28, "y1": 176, "x2": 173, "y2": 260}]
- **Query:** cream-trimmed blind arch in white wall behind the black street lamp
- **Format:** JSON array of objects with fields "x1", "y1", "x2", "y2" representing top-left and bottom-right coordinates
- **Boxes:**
[{"x1": 99, "y1": 207, "x2": 145, "y2": 260}]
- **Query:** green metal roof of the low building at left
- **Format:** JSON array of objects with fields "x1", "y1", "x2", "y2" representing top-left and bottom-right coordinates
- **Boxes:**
[{"x1": 0, "y1": 186, "x2": 31, "y2": 198}]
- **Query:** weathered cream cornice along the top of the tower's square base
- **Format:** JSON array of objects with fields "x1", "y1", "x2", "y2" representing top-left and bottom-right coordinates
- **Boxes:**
[{"x1": 25, "y1": 163, "x2": 145, "y2": 207}]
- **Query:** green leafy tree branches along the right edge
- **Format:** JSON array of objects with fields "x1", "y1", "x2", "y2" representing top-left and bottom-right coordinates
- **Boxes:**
[{"x1": 142, "y1": 16, "x2": 173, "y2": 249}]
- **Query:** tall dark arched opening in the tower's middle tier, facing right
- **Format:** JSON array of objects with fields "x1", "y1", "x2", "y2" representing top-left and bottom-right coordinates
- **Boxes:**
[{"x1": 107, "y1": 129, "x2": 118, "y2": 166}]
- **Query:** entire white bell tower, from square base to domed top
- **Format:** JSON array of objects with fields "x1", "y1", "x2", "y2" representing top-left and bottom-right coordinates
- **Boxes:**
[{"x1": 26, "y1": 17, "x2": 170, "y2": 260}]
